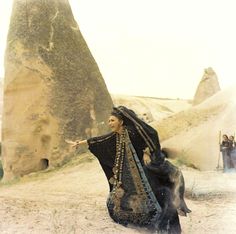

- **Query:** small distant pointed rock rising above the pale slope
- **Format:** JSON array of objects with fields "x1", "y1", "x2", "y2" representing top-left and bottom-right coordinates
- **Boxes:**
[{"x1": 193, "y1": 67, "x2": 220, "y2": 105}]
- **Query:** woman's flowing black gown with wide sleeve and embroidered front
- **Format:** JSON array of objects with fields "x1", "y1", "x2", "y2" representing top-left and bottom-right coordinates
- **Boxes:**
[{"x1": 88, "y1": 124, "x2": 181, "y2": 234}]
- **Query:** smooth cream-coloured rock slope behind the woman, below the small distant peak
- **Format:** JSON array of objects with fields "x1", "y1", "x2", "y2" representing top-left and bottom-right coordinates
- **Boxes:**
[{"x1": 156, "y1": 86, "x2": 236, "y2": 170}]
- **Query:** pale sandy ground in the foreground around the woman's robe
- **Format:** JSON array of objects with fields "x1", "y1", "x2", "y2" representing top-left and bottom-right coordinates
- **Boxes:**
[{"x1": 0, "y1": 154, "x2": 236, "y2": 234}]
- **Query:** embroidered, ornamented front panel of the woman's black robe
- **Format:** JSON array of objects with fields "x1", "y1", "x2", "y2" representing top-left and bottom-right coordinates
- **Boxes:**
[{"x1": 107, "y1": 128, "x2": 161, "y2": 226}]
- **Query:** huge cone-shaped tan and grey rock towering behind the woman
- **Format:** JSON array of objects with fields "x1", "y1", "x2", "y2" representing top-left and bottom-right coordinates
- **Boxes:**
[{"x1": 2, "y1": 0, "x2": 112, "y2": 180}]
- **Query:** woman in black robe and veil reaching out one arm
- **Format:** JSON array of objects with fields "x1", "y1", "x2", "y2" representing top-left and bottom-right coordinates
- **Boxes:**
[{"x1": 69, "y1": 106, "x2": 191, "y2": 234}]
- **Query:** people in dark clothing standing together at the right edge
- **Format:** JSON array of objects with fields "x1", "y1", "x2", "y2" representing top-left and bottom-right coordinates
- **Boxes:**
[{"x1": 220, "y1": 134, "x2": 236, "y2": 172}]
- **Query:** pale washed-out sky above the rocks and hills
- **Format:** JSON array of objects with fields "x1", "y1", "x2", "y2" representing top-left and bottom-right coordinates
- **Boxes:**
[{"x1": 0, "y1": 0, "x2": 236, "y2": 98}]
